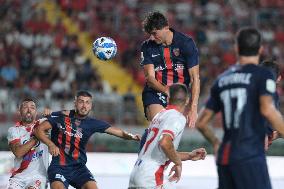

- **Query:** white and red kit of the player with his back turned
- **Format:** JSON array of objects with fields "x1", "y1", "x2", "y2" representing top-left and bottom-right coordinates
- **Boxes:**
[{"x1": 129, "y1": 109, "x2": 186, "y2": 188}]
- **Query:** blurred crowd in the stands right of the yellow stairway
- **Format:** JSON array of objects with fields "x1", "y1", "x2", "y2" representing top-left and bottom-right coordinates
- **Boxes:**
[{"x1": 58, "y1": 0, "x2": 284, "y2": 95}]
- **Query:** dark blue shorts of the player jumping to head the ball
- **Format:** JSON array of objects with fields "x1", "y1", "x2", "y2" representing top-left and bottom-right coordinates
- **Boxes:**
[{"x1": 142, "y1": 89, "x2": 167, "y2": 118}]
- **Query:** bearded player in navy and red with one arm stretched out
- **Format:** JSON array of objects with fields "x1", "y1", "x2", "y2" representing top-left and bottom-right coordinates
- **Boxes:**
[{"x1": 35, "y1": 91, "x2": 140, "y2": 189}]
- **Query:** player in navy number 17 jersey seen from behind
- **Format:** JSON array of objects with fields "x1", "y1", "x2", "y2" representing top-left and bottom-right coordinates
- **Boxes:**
[{"x1": 196, "y1": 28, "x2": 284, "y2": 189}]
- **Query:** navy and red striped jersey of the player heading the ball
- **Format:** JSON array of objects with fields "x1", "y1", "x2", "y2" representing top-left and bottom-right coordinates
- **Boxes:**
[{"x1": 140, "y1": 29, "x2": 199, "y2": 89}]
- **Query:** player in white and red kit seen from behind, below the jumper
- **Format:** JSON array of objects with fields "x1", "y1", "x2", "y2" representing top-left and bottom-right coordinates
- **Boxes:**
[{"x1": 129, "y1": 84, "x2": 206, "y2": 189}]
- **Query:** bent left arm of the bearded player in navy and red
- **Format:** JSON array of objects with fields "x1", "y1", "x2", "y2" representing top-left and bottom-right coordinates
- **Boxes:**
[{"x1": 34, "y1": 121, "x2": 59, "y2": 156}]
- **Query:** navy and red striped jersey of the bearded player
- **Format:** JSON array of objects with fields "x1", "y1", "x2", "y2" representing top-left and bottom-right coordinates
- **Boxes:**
[{"x1": 47, "y1": 110, "x2": 110, "y2": 166}]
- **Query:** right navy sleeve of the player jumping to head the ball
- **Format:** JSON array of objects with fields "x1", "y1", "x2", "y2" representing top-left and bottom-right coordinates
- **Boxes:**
[{"x1": 184, "y1": 38, "x2": 199, "y2": 68}]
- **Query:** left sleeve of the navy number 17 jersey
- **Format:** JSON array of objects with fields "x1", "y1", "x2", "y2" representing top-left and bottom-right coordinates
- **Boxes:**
[{"x1": 205, "y1": 81, "x2": 221, "y2": 112}]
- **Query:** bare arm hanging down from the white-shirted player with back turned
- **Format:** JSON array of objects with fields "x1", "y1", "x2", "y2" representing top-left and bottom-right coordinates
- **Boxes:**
[{"x1": 159, "y1": 135, "x2": 182, "y2": 182}]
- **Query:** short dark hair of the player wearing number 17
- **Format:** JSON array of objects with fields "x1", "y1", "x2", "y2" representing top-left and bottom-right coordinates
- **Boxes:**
[{"x1": 237, "y1": 28, "x2": 261, "y2": 56}]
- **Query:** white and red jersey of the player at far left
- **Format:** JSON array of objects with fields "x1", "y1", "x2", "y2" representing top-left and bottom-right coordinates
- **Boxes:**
[{"x1": 7, "y1": 119, "x2": 49, "y2": 180}]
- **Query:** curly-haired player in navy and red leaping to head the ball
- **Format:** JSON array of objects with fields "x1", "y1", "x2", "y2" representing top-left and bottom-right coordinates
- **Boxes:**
[{"x1": 141, "y1": 12, "x2": 200, "y2": 127}]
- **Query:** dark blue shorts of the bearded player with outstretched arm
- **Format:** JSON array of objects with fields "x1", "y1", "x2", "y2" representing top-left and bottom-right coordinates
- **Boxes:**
[{"x1": 47, "y1": 165, "x2": 96, "y2": 188}]
